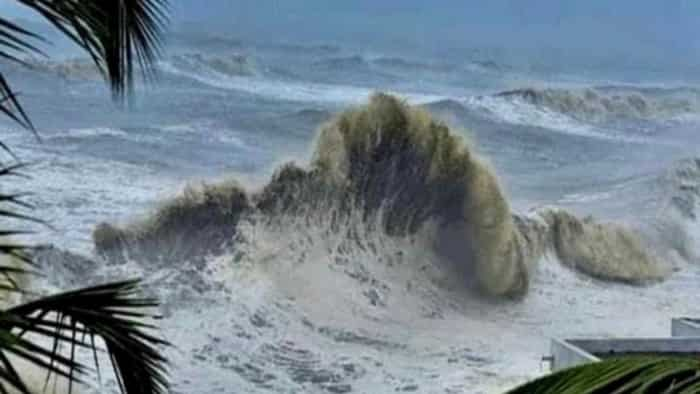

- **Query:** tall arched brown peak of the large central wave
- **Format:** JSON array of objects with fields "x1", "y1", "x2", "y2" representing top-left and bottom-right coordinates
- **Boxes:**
[{"x1": 315, "y1": 94, "x2": 529, "y2": 295}]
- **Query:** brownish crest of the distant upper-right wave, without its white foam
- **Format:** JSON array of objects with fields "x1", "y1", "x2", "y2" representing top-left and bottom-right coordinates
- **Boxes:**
[{"x1": 495, "y1": 87, "x2": 700, "y2": 122}]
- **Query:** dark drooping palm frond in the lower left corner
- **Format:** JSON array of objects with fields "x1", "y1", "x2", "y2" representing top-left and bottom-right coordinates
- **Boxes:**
[{"x1": 0, "y1": 280, "x2": 168, "y2": 394}]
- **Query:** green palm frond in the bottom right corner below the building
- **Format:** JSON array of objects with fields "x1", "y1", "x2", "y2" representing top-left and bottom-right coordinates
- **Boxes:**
[{"x1": 508, "y1": 357, "x2": 700, "y2": 394}]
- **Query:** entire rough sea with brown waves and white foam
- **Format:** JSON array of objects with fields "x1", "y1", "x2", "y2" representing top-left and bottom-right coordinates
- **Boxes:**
[{"x1": 3, "y1": 35, "x2": 700, "y2": 394}]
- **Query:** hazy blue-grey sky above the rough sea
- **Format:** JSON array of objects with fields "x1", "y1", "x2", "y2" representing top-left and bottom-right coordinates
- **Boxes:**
[{"x1": 0, "y1": 0, "x2": 700, "y2": 61}]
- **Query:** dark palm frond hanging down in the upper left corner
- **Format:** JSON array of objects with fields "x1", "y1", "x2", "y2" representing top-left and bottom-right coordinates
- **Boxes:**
[{"x1": 0, "y1": 0, "x2": 168, "y2": 132}]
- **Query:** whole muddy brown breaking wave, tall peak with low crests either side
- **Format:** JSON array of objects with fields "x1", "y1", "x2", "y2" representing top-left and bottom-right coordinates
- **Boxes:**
[{"x1": 93, "y1": 94, "x2": 666, "y2": 296}]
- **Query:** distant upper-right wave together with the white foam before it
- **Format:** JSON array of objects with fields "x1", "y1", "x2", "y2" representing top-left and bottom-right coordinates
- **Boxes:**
[{"x1": 461, "y1": 85, "x2": 700, "y2": 143}]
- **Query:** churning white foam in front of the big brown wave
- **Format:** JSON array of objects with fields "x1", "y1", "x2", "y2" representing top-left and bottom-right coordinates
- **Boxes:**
[{"x1": 146, "y1": 206, "x2": 700, "y2": 394}]
